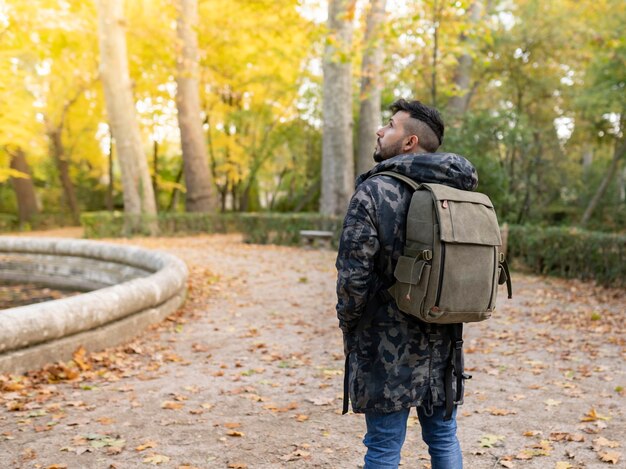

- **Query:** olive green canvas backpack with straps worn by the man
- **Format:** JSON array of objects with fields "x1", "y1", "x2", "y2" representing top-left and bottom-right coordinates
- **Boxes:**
[{"x1": 376, "y1": 171, "x2": 513, "y2": 420}]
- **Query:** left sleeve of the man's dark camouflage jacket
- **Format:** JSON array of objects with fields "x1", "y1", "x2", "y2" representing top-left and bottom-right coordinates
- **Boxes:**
[{"x1": 336, "y1": 183, "x2": 380, "y2": 337}]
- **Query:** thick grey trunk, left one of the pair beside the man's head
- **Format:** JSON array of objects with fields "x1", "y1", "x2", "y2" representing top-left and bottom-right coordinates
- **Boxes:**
[{"x1": 320, "y1": 0, "x2": 355, "y2": 215}]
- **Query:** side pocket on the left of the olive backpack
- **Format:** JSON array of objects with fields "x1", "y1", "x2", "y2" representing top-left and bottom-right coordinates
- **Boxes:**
[{"x1": 389, "y1": 256, "x2": 431, "y2": 318}]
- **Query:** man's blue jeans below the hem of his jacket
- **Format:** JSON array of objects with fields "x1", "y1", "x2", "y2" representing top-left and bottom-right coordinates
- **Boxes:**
[{"x1": 363, "y1": 406, "x2": 463, "y2": 469}]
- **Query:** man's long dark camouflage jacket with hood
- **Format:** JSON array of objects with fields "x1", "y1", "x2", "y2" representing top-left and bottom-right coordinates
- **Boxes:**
[{"x1": 336, "y1": 153, "x2": 478, "y2": 413}]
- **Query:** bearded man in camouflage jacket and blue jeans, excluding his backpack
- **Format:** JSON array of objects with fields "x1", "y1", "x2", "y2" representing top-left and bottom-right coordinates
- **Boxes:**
[{"x1": 336, "y1": 99, "x2": 478, "y2": 469}]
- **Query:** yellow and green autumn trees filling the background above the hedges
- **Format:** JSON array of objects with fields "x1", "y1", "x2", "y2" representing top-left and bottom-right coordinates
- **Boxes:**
[{"x1": 0, "y1": 0, "x2": 626, "y2": 233}]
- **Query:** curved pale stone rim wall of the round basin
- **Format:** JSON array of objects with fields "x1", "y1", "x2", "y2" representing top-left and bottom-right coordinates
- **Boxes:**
[{"x1": 0, "y1": 236, "x2": 188, "y2": 373}]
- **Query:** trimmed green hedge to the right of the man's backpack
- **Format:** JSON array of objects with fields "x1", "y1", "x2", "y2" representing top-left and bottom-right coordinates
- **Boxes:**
[{"x1": 508, "y1": 225, "x2": 626, "y2": 287}]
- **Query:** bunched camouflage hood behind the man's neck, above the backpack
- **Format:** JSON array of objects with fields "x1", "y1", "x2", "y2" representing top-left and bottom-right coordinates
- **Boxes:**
[{"x1": 356, "y1": 153, "x2": 478, "y2": 191}]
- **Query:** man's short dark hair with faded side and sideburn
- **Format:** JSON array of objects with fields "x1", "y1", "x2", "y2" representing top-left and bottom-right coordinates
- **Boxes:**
[{"x1": 389, "y1": 99, "x2": 444, "y2": 153}]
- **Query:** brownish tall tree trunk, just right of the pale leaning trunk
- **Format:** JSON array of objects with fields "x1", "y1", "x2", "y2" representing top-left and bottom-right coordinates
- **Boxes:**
[{"x1": 176, "y1": 0, "x2": 215, "y2": 212}]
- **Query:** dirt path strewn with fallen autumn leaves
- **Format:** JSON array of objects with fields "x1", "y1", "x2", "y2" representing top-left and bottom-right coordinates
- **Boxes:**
[{"x1": 0, "y1": 235, "x2": 626, "y2": 469}]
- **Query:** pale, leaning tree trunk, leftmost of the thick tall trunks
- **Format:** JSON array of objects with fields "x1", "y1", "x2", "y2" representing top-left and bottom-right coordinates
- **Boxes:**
[{"x1": 96, "y1": 0, "x2": 158, "y2": 234}]
